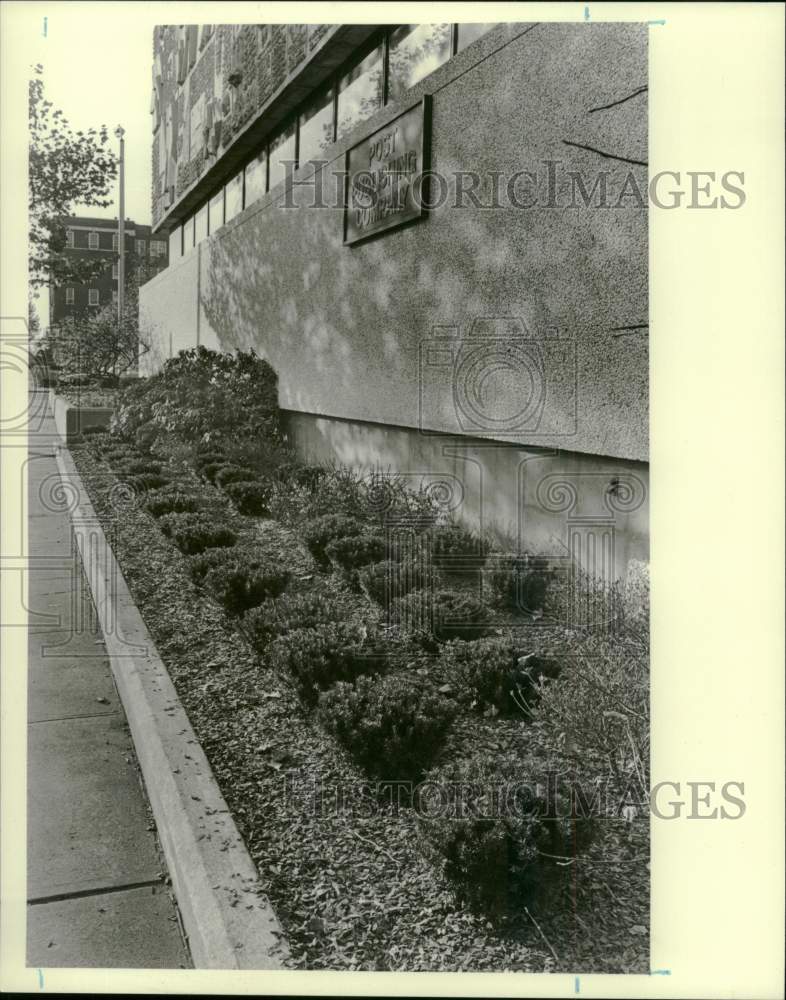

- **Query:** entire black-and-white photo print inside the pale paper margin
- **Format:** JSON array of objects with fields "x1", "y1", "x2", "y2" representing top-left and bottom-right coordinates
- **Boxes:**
[{"x1": 3, "y1": 2, "x2": 777, "y2": 995}]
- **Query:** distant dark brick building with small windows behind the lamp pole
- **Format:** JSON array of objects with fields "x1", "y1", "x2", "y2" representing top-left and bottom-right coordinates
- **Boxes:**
[{"x1": 49, "y1": 216, "x2": 169, "y2": 326}]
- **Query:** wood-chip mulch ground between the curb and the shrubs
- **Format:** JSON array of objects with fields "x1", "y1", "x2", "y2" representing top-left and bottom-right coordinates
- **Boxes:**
[{"x1": 74, "y1": 446, "x2": 649, "y2": 973}]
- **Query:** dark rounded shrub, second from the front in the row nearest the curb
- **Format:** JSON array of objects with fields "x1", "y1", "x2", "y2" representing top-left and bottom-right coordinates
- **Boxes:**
[{"x1": 319, "y1": 674, "x2": 455, "y2": 781}]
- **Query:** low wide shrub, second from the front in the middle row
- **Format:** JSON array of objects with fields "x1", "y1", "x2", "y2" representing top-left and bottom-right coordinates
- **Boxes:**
[{"x1": 393, "y1": 590, "x2": 489, "y2": 642}]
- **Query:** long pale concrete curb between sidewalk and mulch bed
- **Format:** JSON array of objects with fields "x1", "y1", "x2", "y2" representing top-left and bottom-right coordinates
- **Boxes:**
[{"x1": 55, "y1": 447, "x2": 288, "y2": 969}]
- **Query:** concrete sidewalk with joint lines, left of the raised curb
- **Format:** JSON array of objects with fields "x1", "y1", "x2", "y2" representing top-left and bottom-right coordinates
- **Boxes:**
[{"x1": 27, "y1": 392, "x2": 191, "y2": 968}]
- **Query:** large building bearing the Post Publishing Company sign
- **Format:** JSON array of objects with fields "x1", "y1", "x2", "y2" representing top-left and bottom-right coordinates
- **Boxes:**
[{"x1": 140, "y1": 21, "x2": 649, "y2": 572}]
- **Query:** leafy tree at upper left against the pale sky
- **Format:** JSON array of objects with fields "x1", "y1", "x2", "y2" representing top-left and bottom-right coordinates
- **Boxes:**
[{"x1": 28, "y1": 65, "x2": 117, "y2": 288}]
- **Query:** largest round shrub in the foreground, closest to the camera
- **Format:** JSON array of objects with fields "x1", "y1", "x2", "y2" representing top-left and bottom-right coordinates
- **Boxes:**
[{"x1": 416, "y1": 753, "x2": 593, "y2": 917}]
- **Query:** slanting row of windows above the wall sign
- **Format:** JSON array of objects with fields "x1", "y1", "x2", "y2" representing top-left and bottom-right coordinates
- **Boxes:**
[{"x1": 169, "y1": 23, "x2": 495, "y2": 260}]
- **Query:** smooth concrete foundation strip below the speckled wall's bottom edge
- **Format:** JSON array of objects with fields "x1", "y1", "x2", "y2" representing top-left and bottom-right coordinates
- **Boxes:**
[{"x1": 287, "y1": 412, "x2": 649, "y2": 578}]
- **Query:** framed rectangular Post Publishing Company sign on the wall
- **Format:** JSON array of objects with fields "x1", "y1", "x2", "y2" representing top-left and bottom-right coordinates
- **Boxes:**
[{"x1": 344, "y1": 96, "x2": 431, "y2": 245}]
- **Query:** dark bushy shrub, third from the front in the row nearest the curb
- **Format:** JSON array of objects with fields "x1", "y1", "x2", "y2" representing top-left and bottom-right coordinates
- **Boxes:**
[{"x1": 267, "y1": 623, "x2": 387, "y2": 704}]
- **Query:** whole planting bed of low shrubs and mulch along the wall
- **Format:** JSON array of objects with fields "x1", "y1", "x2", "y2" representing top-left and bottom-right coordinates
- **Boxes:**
[{"x1": 70, "y1": 357, "x2": 649, "y2": 972}]
